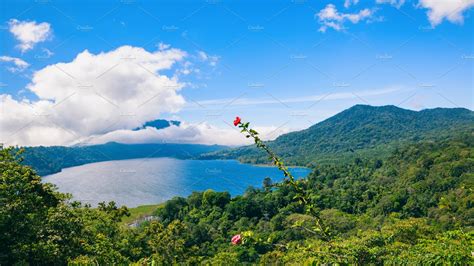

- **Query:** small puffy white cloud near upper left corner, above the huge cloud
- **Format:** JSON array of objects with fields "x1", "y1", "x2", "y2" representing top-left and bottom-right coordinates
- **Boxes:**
[{"x1": 8, "y1": 19, "x2": 52, "y2": 52}]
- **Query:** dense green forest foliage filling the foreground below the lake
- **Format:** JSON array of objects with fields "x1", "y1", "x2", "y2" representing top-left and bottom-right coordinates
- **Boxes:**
[{"x1": 0, "y1": 133, "x2": 474, "y2": 265}]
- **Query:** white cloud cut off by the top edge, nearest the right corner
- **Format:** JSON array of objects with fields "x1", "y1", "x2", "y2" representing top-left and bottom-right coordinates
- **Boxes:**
[{"x1": 419, "y1": 0, "x2": 474, "y2": 26}]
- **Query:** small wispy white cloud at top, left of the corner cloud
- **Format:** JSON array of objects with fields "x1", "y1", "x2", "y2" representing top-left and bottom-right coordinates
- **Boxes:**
[{"x1": 315, "y1": 4, "x2": 374, "y2": 32}]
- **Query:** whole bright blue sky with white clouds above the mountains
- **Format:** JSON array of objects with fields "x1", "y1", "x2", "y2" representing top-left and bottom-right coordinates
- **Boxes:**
[{"x1": 0, "y1": 0, "x2": 474, "y2": 146}]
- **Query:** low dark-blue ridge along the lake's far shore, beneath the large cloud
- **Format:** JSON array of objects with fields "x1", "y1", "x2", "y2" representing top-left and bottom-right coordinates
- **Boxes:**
[{"x1": 23, "y1": 142, "x2": 226, "y2": 175}]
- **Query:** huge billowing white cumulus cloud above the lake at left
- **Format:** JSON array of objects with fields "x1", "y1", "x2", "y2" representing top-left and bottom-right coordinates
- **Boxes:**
[{"x1": 0, "y1": 46, "x2": 186, "y2": 145}]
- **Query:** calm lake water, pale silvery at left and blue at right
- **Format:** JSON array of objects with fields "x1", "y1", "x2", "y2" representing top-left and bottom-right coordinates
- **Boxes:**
[{"x1": 43, "y1": 158, "x2": 311, "y2": 207}]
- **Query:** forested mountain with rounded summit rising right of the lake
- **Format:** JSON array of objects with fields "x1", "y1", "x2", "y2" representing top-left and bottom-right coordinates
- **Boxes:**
[{"x1": 203, "y1": 105, "x2": 474, "y2": 165}]
